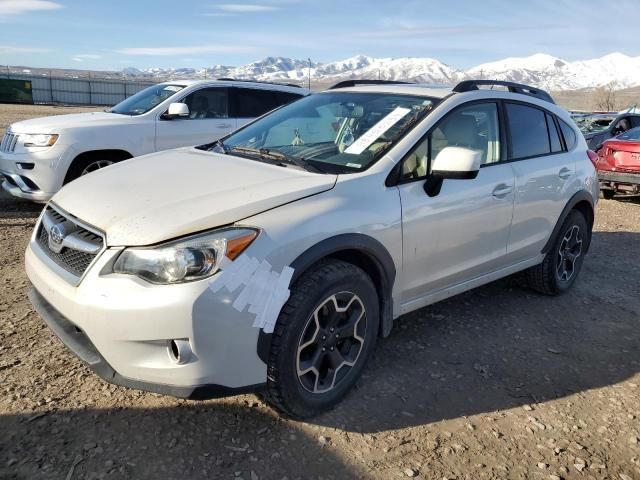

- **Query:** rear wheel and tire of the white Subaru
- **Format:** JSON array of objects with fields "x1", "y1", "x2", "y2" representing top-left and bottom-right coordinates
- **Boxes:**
[{"x1": 526, "y1": 210, "x2": 591, "y2": 295}]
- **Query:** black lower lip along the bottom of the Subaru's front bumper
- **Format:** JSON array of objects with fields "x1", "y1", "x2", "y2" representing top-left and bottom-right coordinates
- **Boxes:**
[{"x1": 28, "y1": 288, "x2": 264, "y2": 400}]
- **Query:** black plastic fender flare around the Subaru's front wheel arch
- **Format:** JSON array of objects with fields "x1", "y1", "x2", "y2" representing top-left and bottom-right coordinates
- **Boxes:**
[{"x1": 258, "y1": 233, "x2": 396, "y2": 363}]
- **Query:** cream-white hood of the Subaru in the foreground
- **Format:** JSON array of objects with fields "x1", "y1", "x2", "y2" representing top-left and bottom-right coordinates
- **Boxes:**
[{"x1": 52, "y1": 148, "x2": 337, "y2": 246}]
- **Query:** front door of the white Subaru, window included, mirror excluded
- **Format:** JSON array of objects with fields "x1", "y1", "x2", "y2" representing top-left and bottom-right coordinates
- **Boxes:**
[{"x1": 398, "y1": 102, "x2": 514, "y2": 303}]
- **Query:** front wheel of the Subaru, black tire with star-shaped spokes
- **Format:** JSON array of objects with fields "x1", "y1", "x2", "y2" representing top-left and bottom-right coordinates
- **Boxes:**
[{"x1": 266, "y1": 260, "x2": 380, "y2": 418}]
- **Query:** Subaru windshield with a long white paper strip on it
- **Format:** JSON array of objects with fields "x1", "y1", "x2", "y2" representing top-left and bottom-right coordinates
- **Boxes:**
[{"x1": 214, "y1": 92, "x2": 438, "y2": 173}]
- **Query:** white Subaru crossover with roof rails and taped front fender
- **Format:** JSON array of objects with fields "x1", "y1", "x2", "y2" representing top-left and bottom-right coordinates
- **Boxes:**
[{"x1": 26, "y1": 81, "x2": 598, "y2": 417}]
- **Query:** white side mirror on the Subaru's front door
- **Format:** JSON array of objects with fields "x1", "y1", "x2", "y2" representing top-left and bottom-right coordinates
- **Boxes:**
[{"x1": 424, "y1": 147, "x2": 482, "y2": 197}]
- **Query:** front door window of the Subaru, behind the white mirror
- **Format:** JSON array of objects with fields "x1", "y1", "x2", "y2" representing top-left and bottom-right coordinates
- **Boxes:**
[{"x1": 400, "y1": 102, "x2": 500, "y2": 180}]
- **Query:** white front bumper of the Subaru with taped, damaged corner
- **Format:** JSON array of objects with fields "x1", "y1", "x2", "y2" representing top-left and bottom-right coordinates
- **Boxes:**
[{"x1": 25, "y1": 239, "x2": 267, "y2": 398}]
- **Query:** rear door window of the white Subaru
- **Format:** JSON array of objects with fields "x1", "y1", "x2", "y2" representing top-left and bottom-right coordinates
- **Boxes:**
[{"x1": 505, "y1": 103, "x2": 551, "y2": 160}]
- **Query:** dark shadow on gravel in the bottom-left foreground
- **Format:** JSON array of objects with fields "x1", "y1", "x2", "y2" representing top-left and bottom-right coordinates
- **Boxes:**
[{"x1": 0, "y1": 402, "x2": 362, "y2": 480}]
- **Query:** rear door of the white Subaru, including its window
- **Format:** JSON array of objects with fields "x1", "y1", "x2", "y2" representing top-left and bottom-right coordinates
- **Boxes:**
[{"x1": 504, "y1": 101, "x2": 578, "y2": 263}]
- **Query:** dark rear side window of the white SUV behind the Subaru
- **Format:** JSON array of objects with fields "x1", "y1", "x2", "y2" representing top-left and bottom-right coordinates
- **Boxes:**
[{"x1": 231, "y1": 87, "x2": 302, "y2": 128}]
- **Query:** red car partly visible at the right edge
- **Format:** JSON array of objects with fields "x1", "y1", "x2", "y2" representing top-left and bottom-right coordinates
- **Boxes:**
[{"x1": 596, "y1": 127, "x2": 640, "y2": 199}]
